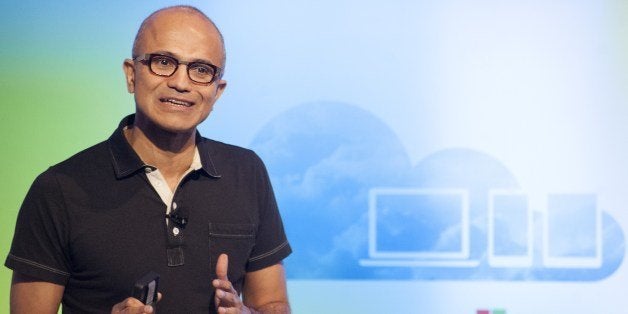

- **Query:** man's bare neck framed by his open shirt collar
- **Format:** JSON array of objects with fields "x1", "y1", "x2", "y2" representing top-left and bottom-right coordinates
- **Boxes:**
[{"x1": 124, "y1": 126, "x2": 196, "y2": 190}]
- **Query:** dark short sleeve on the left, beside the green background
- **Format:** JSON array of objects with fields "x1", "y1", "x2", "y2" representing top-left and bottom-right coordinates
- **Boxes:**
[{"x1": 5, "y1": 169, "x2": 70, "y2": 285}]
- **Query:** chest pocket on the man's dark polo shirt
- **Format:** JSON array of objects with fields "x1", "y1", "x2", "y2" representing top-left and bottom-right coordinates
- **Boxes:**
[{"x1": 209, "y1": 223, "x2": 257, "y2": 291}]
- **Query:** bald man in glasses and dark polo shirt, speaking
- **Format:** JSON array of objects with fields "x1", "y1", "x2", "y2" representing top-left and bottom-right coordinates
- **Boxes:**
[{"x1": 5, "y1": 6, "x2": 291, "y2": 313}]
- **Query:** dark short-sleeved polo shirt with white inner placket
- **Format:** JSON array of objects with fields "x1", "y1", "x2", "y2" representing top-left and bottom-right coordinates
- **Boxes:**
[{"x1": 5, "y1": 116, "x2": 291, "y2": 313}]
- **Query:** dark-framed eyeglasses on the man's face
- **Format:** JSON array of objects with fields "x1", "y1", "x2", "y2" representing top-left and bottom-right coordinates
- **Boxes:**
[{"x1": 133, "y1": 53, "x2": 222, "y2": 85}]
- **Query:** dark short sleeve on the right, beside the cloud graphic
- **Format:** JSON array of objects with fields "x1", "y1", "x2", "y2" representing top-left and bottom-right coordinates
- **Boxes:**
[{"x1": 247, "y1": 154, "x2": 292, "y2": 272}]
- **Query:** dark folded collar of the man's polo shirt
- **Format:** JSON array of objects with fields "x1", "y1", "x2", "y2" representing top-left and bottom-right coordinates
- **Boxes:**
[{"x1": 108, "y1": 114, "x2": 221, "y2": 179}]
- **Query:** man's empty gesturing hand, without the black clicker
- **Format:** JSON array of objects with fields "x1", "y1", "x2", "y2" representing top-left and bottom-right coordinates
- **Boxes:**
[{"x1": 212, "y1": 254, "x2": 250, "y2": 314}]
